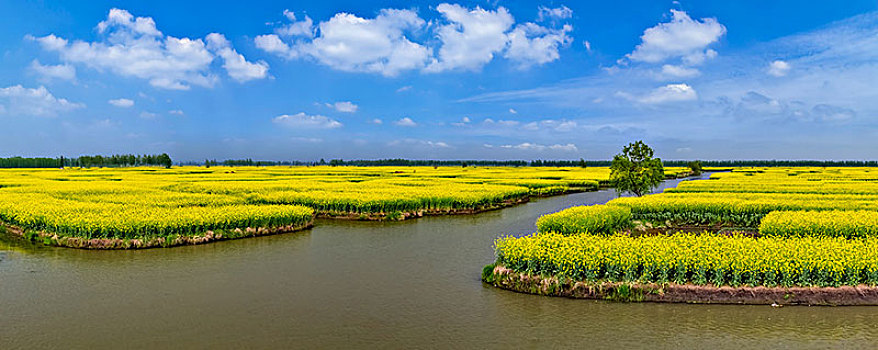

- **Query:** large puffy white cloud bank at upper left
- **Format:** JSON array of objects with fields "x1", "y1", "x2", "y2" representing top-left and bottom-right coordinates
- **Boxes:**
[{"x1": 30, "y1": 8, "x2": 268, "y2": 90}]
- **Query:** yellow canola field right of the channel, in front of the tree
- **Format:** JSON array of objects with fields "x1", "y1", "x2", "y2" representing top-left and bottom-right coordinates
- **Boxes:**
[{"x1": 495, "y1": 168, "x2": 878, "y2": 287}]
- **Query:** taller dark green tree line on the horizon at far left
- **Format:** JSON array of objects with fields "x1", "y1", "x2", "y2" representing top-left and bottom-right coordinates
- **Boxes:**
[{"x1": 0, "y1": 153, "x2": 173, "y2": 168}]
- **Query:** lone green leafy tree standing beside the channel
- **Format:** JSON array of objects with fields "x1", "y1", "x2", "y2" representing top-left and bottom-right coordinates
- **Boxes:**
[{"x1": 610, "y1": 141, "x2": 665, "y2": 197}]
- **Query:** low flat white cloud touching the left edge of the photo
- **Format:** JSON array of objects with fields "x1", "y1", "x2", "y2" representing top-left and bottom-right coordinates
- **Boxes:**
[{"x1": 0, "y1": 85, "x2": 85, "y2": 117}]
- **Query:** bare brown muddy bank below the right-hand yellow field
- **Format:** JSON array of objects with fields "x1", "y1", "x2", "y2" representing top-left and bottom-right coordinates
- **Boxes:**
[{"x1": 482, "y1": 265, "x2": 878, "y2": 306}]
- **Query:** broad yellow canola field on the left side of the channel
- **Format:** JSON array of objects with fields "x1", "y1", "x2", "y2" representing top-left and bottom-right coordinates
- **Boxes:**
[{"x1": 0, "y1": 166, "x2": 686, "y2": 248}]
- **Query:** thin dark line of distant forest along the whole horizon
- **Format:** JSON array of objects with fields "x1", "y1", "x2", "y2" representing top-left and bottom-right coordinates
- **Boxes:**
[{"x1": 0, "y1": 153, "x2": 878, "y2": 168}]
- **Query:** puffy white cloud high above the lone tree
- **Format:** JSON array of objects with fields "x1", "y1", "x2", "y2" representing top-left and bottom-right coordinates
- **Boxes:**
[{"x1": 625, "y1": 10, "x2": 726, "y2": 65}]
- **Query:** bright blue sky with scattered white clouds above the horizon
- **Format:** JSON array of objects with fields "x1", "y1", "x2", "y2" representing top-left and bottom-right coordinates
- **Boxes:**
[{"x1": 0, "y1": 0, "x2": 878, "y2": 160}]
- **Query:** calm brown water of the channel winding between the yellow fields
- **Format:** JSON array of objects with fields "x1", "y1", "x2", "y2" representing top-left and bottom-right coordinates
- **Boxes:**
[{"x1": 0, "y1": 176, "x2": 878, "y2": 349}]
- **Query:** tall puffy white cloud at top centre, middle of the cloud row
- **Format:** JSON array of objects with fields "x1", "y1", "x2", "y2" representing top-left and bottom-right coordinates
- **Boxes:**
[{"x1": 427, "y1": 3, "x2": 515, "y2": 72}]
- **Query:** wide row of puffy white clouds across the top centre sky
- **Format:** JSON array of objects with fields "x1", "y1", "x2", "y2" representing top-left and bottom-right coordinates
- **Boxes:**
[{"x1": 255, "y1": 3, "x2": 573, "y2": 76}]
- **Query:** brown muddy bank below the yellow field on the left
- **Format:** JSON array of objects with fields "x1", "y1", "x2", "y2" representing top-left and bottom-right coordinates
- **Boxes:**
[{"x1": 0, "y1": 219, "x2": 314, "y2": 249}]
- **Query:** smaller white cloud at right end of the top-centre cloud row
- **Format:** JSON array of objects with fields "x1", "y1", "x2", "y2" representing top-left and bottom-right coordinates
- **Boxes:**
[{"x1": 504, "y1": 23, "x2": 573, "y2": 68}]
